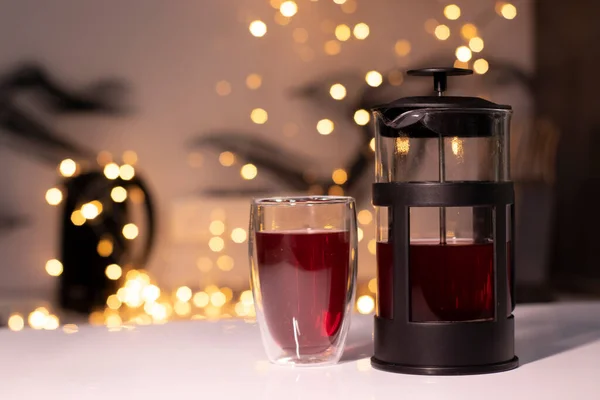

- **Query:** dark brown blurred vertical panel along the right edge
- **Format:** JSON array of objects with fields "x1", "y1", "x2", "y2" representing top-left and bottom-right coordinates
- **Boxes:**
[{"x1": 534, "y1": 0, "x2": 600, "y2": 296}]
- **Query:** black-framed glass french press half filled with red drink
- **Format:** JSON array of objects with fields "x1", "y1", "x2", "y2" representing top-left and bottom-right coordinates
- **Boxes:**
[{"x1": 371, "y1": 68, "x2": 518, "y2": 375}]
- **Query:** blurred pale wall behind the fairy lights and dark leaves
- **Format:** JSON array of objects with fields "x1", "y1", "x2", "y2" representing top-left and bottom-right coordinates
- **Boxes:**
[{"x1": 0, "y1": 0, "x2": 533, "y2": 294}]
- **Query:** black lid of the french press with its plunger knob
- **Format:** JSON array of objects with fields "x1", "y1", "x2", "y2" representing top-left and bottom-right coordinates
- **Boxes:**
[{"x1": 373, "y1": 67, "x2": 512, "y2": 138}]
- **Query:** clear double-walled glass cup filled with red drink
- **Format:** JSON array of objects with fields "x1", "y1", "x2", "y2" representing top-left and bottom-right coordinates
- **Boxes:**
[{"x1": 249, "y1": 196, "x2": 357, "y2": 366}]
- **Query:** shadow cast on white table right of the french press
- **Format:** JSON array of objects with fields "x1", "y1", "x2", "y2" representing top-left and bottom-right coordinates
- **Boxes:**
[{"x1": 515, "y1": 303, "x2": 600, "y2": 365}]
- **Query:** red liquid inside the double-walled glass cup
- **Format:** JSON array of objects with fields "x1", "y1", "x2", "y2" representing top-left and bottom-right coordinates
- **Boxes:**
[{"x1": 256, "y1": 231, "x2": 350, "y2": 354}]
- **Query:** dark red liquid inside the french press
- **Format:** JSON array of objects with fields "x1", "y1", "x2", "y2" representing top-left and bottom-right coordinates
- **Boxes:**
[{"x1": 377, "y1": 242, "x2": 494, "y2": 322}]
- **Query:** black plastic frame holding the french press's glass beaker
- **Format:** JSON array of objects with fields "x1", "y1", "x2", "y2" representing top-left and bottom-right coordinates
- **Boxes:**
[{"x1": 371, "y1": 182, "x2": 518, "y2": 375}]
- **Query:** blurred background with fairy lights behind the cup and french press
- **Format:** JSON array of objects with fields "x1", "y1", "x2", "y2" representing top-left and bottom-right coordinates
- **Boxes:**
[{"x1": 0, "y1": 0, "x2": 600, "y2": 332}]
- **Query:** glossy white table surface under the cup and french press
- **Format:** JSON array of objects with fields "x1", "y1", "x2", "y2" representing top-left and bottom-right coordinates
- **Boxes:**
[{"x1": 0, "y1": 303, "x2": 600, "y2": 400}]
